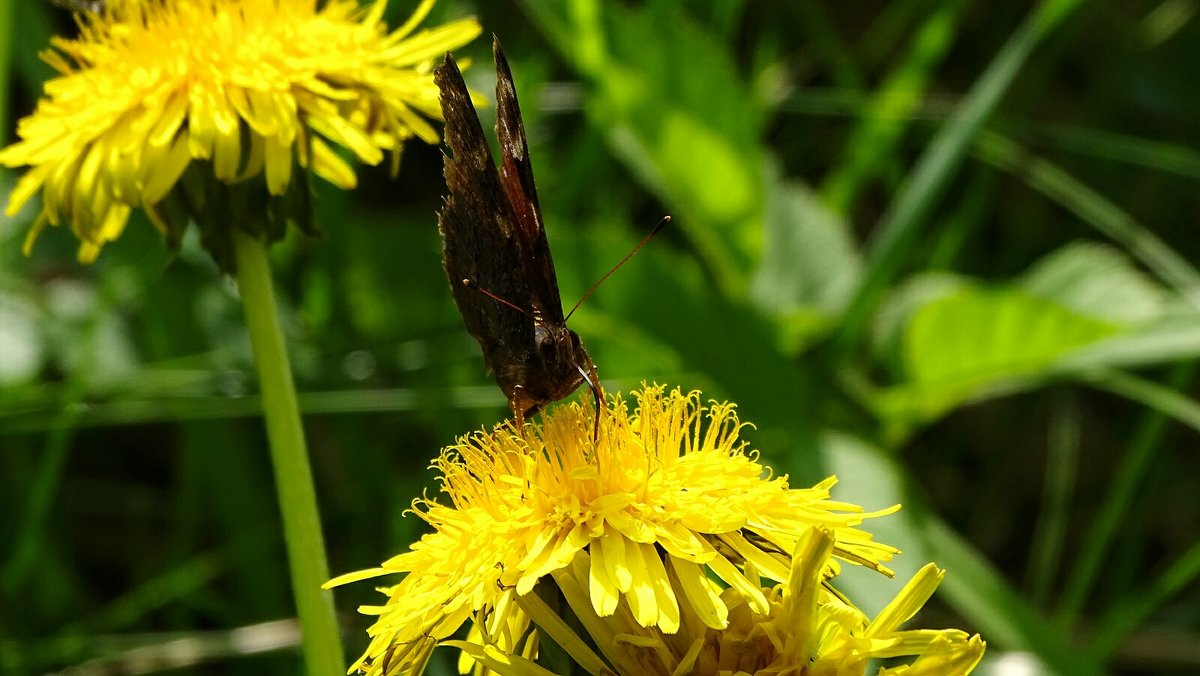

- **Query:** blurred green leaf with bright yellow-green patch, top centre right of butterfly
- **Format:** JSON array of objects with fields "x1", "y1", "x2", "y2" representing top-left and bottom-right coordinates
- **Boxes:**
[{"x1": 526, "y1": 2, "x2": 764, "y2": 293}]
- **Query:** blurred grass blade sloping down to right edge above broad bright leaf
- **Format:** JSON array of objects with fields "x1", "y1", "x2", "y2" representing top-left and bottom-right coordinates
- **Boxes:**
[{"x1": 978, "y1": 132, "x2": 1200, "y2": 309}]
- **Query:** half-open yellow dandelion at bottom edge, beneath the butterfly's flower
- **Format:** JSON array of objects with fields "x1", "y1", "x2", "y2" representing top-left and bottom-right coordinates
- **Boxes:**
[{"x1": 445, "y1": 526, "x2": 985, "y2": 676}]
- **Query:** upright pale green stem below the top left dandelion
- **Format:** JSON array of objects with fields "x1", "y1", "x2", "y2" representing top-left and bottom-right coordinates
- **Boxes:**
[{"x1": 233, "y1": 227, "x2": 346, "y2": 675}]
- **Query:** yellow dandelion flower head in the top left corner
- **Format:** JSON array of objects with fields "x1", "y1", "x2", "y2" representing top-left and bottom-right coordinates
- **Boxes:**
[{"x1": 0, "y1": 0, "x2": 480, "y2": 262}]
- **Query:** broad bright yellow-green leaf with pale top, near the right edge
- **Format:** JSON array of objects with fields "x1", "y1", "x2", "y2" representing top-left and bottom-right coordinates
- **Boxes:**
[{"x1": 875, "y1": 243, "x2": 1171, "y2": 421}]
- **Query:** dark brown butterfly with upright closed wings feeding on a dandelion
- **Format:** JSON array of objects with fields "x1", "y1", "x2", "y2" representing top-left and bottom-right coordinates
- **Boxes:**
[{"x1": 433, "y1": 41, "x2": 602, "y2": 430}]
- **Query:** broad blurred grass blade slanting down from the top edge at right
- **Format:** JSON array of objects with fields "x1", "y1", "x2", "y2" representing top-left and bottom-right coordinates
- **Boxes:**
[{"x1": 833, "y1": 0, "x2": 1082, "y2": 363}]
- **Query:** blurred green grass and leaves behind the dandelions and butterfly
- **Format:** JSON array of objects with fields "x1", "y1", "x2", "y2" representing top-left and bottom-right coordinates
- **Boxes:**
[{"x1": 0, "y1": 0, "x2": 1200, "y2": 674}]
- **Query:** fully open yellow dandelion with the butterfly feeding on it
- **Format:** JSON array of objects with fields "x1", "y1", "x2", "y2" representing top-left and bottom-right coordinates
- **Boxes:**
[{"x1": 328, "y1": 387, "x2": 896, "y2": 674}]
